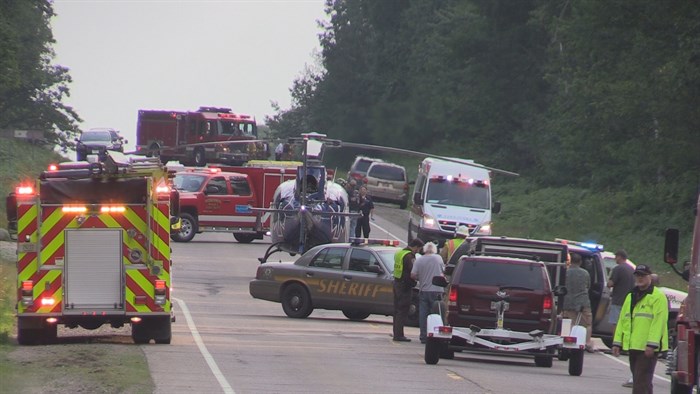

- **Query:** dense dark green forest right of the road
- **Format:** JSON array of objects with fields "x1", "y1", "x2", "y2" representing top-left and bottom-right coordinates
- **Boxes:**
[{"x1": 266, "y1": 0, "x2": 700, "y2": 198}]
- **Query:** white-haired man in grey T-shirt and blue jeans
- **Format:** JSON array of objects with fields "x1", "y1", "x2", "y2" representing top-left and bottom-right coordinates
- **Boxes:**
[{"x1": 411, "y1": 242, "x2": 445, "y2": 343}]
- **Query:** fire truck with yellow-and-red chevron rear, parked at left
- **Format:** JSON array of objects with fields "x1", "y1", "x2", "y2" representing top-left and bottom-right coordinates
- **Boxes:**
[{"x1": 7, "y1": 152, "x2": 178, "y2": 345}]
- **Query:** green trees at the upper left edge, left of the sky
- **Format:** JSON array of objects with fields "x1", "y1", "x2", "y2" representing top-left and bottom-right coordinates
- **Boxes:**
[{"x1": 0, "y1": 0, "x2": 80, "y2": 151}]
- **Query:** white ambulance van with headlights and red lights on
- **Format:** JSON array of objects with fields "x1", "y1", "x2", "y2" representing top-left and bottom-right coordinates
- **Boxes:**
[{"x1": 408, "y1": 158, "x2": 501, "y2": 244}]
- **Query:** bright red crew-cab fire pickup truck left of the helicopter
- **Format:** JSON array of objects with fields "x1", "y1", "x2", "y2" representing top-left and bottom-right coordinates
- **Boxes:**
[{"x1": 171, "y1": 160, "x2": 301, "y2": 243}]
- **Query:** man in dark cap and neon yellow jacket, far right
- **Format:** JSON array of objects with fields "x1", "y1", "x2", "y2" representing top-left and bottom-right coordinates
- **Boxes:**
[{"x1": 612, "y1": 264, "x2": 668, "y2": 393}]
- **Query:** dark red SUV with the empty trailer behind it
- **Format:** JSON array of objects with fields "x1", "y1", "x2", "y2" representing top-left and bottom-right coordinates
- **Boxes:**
[{"x1": 445, "y1": 255, "x2": 556, "y2": 333}]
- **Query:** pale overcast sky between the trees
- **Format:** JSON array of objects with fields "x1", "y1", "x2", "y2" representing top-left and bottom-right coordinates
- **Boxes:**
[{"x1": 51, "y1": 0, "x2": 327, "y2": 150}]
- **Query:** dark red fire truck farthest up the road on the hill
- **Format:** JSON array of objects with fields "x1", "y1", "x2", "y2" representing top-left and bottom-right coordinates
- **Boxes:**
[{"x1": 136, "y1": 107, "x2": 269, "y2": 167}]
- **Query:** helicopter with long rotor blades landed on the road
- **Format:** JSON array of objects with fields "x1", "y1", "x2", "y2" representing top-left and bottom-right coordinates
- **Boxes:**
[{"x1": 123, "y1": 133, "x2": 518, "y2": 263}]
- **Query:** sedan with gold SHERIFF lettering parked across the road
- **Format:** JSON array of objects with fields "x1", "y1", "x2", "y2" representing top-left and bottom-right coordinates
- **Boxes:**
[{"x1": 250, "y1": 238, "x2": 418, "y2": 326}]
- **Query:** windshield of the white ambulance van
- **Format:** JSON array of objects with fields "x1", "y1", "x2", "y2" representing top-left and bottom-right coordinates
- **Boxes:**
[{"x1": 426, "y1": 179, "x2": 491, "y2": 209}]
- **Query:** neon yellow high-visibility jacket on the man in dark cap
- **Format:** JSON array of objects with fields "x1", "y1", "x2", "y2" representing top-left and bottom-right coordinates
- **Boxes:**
[{"x1": 613, "y1": 287, "x2": 668, "y2": 352}]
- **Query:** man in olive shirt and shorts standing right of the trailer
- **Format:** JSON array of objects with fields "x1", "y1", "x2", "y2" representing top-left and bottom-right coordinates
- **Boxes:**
[{"x1": 562, "y1": 253, "x2": 595, "y2": 353}]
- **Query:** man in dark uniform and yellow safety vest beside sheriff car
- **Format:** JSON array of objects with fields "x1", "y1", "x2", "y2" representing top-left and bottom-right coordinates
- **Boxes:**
[{"x1": 394, "y1": 238, "x2": 423, "y2": 342}]
